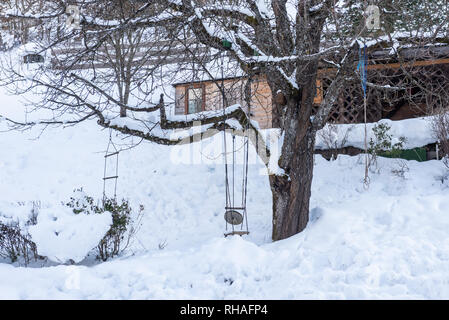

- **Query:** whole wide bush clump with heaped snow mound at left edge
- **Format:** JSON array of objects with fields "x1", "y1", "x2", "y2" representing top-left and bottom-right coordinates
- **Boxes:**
[{"x1": 0, "y1": 189, "x2": 143, "y2": 265}]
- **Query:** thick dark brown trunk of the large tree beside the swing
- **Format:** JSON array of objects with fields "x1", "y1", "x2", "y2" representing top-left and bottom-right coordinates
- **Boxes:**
[{"x1": 270, "y1": 64, "x2": 317, "y2": 241}]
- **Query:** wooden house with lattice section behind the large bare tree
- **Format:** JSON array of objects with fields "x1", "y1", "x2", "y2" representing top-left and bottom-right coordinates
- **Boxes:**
[{"x1": 173, "y1": 46, "x2": 449, "y2": 129}]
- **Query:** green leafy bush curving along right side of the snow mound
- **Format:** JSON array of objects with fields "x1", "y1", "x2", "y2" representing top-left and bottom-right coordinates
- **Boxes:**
[{"x1": 66, "y1": 189, "x2": 144, "y2": 261}]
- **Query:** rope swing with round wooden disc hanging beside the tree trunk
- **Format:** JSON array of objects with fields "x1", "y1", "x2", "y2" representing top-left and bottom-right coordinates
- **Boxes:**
[{"x1": 221, "y1": 39, "x2": 251, "y2": 237}]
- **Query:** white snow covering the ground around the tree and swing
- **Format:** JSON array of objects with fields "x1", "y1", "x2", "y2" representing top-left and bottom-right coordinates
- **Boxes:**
[{"x1": 0, "y1": 87, "x2": 449, "y2": 299}]
